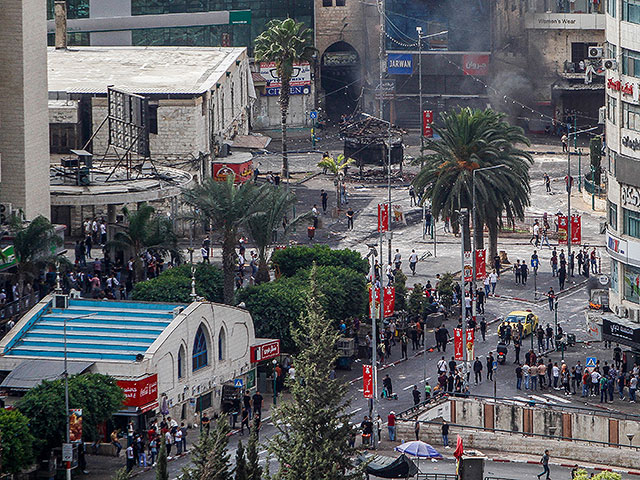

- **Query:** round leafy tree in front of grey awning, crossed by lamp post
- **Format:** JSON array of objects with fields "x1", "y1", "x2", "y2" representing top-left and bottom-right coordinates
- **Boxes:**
[{"x1": 16, "y1": 373, "x2": 124, "y2": 456}]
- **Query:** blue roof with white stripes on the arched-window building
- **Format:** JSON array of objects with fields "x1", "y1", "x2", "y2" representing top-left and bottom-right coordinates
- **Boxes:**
[{"x1": 4, "y1": 299, "x2": 184, "y2": 361}]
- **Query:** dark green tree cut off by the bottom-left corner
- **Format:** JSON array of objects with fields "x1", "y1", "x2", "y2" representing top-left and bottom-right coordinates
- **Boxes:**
[{"x1": 0, "y1": 409, "x2": 34, "y2": 475}]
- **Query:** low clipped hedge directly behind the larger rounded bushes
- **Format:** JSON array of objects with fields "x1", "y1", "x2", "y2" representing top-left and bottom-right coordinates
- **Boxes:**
[{"x1": 271, "y1": 245, "x2": 369, "y2": 277}]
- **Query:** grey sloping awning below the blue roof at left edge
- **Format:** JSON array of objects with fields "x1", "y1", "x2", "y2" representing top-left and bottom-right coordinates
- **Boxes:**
[{"x1": 0, "y1": 360, "x2": 94, "y2": 390}]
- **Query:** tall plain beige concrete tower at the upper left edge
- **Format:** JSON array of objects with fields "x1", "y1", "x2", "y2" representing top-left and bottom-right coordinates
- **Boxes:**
[{"x1": 0, "y1": 0, "x2": 50, "y2": 219}]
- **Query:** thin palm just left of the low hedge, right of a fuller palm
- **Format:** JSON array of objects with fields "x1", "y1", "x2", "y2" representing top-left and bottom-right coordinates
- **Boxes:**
[{"x1": 247, "y1": 185, "x2": 311, "y2": 283}]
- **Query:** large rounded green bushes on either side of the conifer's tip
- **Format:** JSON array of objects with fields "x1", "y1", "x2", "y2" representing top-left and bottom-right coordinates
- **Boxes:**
[{"x1": 238, "y1": 266, "x2": 369, "y2": 351}]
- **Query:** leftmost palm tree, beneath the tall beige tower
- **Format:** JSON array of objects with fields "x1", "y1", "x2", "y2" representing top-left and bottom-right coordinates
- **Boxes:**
[{"x1": 10, "y1": 215, "x2": 66, "y2": 295}]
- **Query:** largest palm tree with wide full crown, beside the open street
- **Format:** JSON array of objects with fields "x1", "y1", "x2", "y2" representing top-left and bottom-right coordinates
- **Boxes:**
[{"x1": 413, "y1": 108, "x2": 533, "y2": 258}]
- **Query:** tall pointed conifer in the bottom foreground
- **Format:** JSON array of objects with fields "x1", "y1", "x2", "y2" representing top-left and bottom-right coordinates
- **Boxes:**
[{"x1": 269, "y1": 267, "x2": 362, "y2": 480}]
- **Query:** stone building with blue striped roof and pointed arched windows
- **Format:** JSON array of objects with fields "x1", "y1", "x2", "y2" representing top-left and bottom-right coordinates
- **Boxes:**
[{"x1": 0, "y1": 296, "x2": 279, "y2": 426}]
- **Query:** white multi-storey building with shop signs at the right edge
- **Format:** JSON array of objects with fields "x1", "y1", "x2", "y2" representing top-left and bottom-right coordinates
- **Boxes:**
[{"x1": 603, "y1": 0, "x2": 640, "y2": 352}]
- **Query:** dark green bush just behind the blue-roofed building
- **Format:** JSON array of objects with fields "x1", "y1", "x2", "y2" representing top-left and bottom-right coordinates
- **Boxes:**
[{"x1": 131, "y1": 264, "x2": 223, "y2": 303}]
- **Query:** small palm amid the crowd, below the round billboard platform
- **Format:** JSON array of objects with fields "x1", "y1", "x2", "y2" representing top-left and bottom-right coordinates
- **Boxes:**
[{"x1": 107, "y1": 203, "x2": 180, "y2": 280}]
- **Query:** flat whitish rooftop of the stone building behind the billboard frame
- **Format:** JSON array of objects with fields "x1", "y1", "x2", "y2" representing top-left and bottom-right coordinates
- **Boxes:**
[{"x1": 47, "y1": 47, "x2": 246, "y2": 95}]
